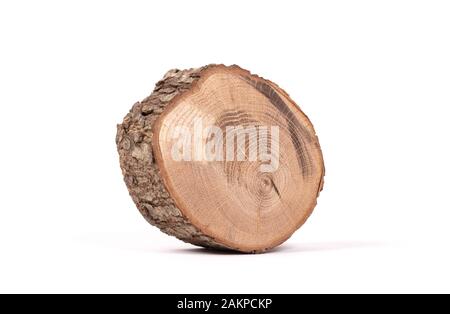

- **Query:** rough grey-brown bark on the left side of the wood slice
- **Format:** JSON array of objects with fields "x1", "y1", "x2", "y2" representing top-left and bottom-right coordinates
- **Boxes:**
[{"x1": 116, "y1": 66, "x2": 232, "y2": 250}]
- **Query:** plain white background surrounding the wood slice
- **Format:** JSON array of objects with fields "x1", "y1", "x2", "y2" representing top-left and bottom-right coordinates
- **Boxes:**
[{"x1": 0, "y1": 0, "x2": 450, "y2": 293}]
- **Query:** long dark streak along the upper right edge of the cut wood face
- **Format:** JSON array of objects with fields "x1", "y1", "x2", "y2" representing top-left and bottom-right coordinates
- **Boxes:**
[{"x1": 241, "y1": 76, "x2": 313, "y2": 178}]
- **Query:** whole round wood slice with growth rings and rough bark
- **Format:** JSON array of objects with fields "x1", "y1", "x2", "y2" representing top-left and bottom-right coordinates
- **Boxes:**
[{"x1": 116, "y1": 65, "x2": 324, "y2": 252}]
